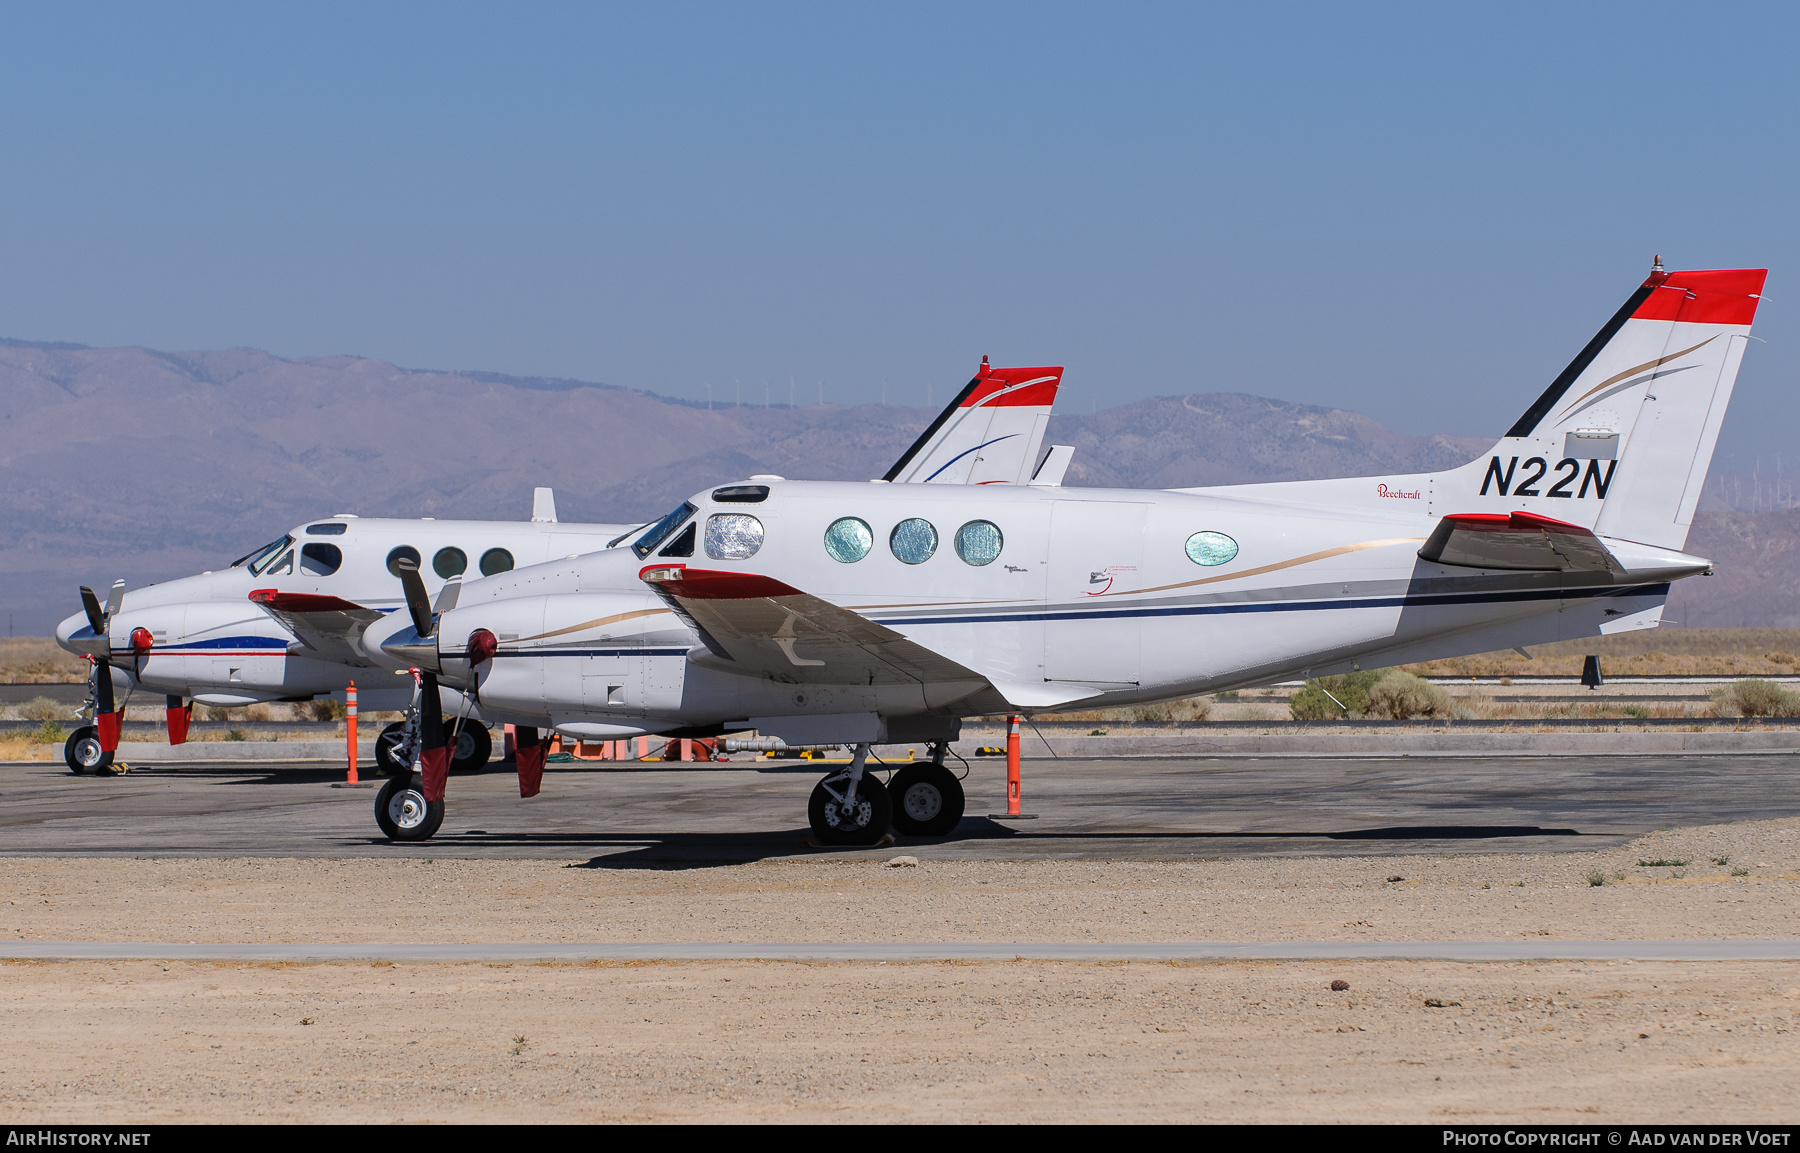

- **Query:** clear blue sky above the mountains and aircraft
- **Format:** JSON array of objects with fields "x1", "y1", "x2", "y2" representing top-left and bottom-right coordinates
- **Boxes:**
[{"x1": 0, "y1": 4, "x2": 1800, "y2": 466}]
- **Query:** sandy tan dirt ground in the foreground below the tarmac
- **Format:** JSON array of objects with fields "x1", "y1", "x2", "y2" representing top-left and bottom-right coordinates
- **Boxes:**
[{"x1": 0, "y1": 820, "x2": 1800, "y2": 1124}]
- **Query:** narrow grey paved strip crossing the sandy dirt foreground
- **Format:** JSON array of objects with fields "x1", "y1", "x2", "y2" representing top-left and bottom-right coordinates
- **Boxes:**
[{"x1": 0, "y1": 941, "x2": 1800, "y2": 964}]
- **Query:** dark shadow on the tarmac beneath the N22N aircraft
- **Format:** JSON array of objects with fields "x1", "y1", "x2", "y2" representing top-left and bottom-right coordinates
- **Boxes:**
[{"x1": 358, "y1": 817, "x2": 1582, "y2": 871}]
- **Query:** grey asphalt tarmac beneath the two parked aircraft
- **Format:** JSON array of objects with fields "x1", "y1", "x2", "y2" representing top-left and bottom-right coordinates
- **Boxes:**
[{"x1": 0, "y1": 754, "x2": 1800, "y2": 867}]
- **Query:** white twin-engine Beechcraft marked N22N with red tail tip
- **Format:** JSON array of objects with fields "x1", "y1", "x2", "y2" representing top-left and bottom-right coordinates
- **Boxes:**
[{"x1": 354, "y1": 259, "x2": 1766, "y2": 844}]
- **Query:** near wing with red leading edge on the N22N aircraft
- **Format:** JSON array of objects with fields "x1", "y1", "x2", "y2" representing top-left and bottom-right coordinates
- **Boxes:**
[{"x1": 639, "y1": 565, "x2": 988, "y2": 685}]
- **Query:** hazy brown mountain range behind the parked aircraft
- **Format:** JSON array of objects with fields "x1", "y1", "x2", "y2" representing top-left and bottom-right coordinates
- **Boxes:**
[{"x1": 0, "y1": 340, "x2": 1800, "y2": 635}]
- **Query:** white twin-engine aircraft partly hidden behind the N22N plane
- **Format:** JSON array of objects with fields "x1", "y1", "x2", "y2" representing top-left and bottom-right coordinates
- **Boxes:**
[{"x1": 56, "y1": 358, "x2": 1073, "y2": 773}]
